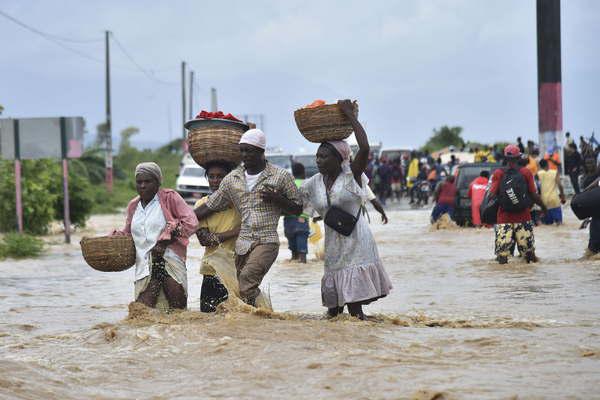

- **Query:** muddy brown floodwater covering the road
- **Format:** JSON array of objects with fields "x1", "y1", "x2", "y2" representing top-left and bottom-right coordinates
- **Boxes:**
[{"x1": 0, "y1": 210, "x2": 600, "y2": 400}]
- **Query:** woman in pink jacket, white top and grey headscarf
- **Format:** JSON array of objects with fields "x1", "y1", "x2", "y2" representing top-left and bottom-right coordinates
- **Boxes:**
[{"x1": 113, "y1": 162, "x2": 198, "y2": 311}]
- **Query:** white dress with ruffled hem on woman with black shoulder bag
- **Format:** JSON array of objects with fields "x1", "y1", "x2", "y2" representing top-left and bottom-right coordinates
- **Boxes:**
[{"x1": 300, "y1": 168, "x2": 392, "y2": 308}]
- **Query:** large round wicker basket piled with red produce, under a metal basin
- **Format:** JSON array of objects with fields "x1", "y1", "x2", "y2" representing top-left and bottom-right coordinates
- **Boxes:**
[{"x1": 185, "y1": 119, "x2": 248, "y2": 166}]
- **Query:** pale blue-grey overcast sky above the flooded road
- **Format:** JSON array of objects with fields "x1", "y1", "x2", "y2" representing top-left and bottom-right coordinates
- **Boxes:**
[{"x1": 0, "y1": 0, "x2": 600, "y2": 151}]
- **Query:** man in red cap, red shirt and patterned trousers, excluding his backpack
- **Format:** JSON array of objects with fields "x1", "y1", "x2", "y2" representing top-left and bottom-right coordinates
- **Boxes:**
[{"x1": 490, "y1": 144, "x2": 546, "y2": 264}]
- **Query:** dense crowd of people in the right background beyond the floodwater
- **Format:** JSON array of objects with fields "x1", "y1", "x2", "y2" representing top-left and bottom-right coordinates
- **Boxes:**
[{"x1": 366, "y1": 132, "x2": 600, "y2": 217}]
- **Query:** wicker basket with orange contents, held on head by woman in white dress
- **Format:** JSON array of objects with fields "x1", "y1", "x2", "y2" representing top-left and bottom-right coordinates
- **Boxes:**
[{"x1": 294, "y1": 102, "x2": 358, "y2": 143}]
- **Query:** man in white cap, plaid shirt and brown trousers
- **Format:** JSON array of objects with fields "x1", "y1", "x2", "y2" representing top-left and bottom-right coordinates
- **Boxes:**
[{"x1": 195, "y1": 129, "x2": 302, "y2": 305}]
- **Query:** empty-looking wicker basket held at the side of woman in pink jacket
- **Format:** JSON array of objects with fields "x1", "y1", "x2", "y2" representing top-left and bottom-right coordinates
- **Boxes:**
[{"x1": 79, "y1": 236, "x2": 135, "y2": 272}]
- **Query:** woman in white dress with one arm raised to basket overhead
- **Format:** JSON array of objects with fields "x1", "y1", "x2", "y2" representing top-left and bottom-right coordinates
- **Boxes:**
[{"x1": 301, "y1": 100, "x2": 392, "y2": 319}]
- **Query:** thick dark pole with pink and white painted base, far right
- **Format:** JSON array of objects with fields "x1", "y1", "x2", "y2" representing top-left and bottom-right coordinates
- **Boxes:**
[{"x1": 536, "y1": 0, "x2": 564, "y2": 170}]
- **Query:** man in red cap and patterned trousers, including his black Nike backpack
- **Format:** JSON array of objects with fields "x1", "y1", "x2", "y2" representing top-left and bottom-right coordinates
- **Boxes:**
[{"x1": 490, "y1": 144, "x2": 546, "y2": 264}]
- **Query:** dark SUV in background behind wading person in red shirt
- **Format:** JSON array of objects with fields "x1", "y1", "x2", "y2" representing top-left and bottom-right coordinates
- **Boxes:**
[{"x1": 453, "y1": 163, "x2": 502, "y2": 226}]
